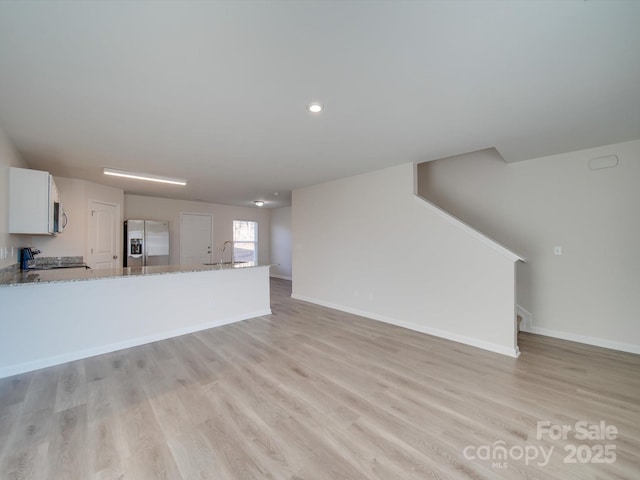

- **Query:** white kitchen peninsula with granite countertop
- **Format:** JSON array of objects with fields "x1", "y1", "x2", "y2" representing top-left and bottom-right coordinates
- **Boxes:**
[{"x1": 0, "y1": 264, "x2": 271, "y2": 378}]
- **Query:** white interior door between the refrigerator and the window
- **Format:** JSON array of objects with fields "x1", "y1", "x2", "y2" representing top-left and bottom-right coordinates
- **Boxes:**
[{"x1": 180, "y1": 213, "x2": 213, "y2": 265}]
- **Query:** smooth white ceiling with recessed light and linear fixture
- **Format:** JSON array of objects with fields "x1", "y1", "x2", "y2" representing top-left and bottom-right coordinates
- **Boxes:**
[{"x1": 0, "y1": 0, "x2": 640, "y2": 206}]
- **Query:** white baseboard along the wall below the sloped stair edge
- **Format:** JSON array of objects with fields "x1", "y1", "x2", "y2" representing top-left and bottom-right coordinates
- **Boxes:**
[{"x1": 291, "y1": 294, "x2": 520, "y2": 358}]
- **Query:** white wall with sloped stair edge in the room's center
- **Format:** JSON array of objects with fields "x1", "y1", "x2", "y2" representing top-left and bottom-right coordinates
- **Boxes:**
[{"x1": 292, "y1": 164, "x2": 517, "y2": 355}]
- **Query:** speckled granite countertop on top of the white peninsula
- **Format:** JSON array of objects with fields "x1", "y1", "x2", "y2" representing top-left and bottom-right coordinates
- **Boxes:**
[{"x1": 0, "y1": 262, "x2": 270, "y2": 287}]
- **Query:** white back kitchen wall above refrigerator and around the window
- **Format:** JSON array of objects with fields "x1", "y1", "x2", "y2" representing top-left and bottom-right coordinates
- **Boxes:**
[{"x1": 124, "y1": 195, "x2": 271, "y2": 264}]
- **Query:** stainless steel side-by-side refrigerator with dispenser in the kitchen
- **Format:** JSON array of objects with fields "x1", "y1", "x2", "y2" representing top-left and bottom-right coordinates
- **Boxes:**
[{"x1": 124, "y1": 220, "x2": 169, "y2": 267}]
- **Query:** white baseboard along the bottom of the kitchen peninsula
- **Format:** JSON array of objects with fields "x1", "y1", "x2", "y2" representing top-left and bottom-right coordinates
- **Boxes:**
[{"x1": 0, "y1": 308, "x2": 271, "y2": 378}]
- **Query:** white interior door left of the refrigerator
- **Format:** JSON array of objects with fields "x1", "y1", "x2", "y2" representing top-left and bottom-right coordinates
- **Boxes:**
[{"x1": 87, "y1": 201, "x2": 120, "y2": 269}]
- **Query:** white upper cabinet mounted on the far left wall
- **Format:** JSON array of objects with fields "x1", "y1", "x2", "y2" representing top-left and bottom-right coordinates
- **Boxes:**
[{"x1": 9, "y1": 168, "x2": 59, "y2": 235}]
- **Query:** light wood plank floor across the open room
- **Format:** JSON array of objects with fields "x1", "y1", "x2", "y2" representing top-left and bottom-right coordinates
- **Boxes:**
[{"x1": 0, "y1": 279, "x2": 640, "y2": 480}]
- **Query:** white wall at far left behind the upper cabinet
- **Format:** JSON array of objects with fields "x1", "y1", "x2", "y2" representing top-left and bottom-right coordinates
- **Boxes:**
[{"x1": 0, "y1": 125, "x2": 31, "y2": 268}]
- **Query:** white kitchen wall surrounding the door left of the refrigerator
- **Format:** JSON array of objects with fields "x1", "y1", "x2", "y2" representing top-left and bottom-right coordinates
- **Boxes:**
[{"x1": 31, "y1": 177, "x2": 124, "y2": 260}]
